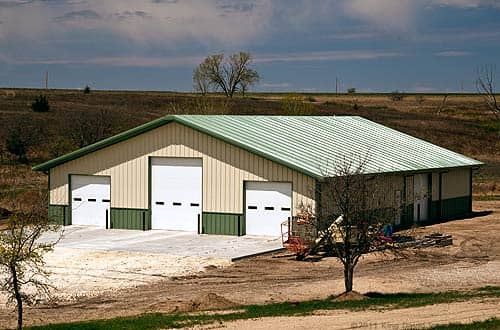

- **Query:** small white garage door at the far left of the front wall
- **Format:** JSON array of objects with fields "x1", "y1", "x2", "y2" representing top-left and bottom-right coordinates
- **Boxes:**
[{"x1": 71, "y1": 175, "x2": 111, "y2": 227}]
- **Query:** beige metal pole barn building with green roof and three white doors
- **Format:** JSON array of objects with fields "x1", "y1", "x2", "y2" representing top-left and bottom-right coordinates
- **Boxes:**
[{"x1": 33, "y1": 115, "x2": 482, "y2": 236}]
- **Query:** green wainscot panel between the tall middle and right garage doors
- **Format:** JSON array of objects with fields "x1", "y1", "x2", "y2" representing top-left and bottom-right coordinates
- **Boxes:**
[{"x1": 201, "y1": 212, "x2": 246, "y2": 236}]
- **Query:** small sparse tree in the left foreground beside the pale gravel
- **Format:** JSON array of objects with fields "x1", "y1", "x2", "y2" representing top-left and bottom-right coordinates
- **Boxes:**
[{"x1": 0, "y1": 191, "x2": 58, "y2": 329}]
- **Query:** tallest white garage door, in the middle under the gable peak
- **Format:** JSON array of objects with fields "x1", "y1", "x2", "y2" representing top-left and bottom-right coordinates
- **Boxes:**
[{"x1": 151, "y1": 158, "x2": 202, "y2": 231}]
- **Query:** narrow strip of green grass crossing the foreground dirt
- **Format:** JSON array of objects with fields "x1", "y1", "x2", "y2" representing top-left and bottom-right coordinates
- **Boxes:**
[{"x1": 28, "y1": 287, "x2": 500, "y2": 330}]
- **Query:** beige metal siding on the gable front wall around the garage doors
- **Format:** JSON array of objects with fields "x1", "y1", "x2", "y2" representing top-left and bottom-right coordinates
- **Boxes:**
[{"x1": 50, "y1": 123, "x2": 315, "y2": 213}]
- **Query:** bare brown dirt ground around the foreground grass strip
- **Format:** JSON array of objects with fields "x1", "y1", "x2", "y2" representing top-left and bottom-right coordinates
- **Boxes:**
[{"x1": 0, "y1": 201, "x2": 500, "y2": 328}]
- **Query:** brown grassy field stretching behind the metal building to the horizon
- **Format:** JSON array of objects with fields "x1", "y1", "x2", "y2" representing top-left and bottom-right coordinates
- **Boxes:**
[{"x1": 0, "y1": 89, "x2": 500, "y2": 206}]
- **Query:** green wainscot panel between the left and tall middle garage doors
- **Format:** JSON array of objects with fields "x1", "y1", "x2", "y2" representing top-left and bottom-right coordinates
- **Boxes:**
[{"x1": 110, "y1": 207, "x2": 151, "y2": 230}]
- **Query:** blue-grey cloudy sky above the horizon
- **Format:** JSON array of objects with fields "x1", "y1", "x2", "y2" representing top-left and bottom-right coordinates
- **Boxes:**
[{"x1": 0, "y1": 0, "x2": 500, "y2": 92}]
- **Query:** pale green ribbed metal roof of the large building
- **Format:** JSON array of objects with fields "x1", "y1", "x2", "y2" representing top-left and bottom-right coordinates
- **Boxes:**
[{"x1": 33, "y1": 115, "x2": 482, "y2": 178}]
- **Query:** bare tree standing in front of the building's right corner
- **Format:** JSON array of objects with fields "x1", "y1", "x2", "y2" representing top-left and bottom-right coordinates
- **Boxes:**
[{"x1": 319, "y1": 159, "x2": 399, "y2": 292}]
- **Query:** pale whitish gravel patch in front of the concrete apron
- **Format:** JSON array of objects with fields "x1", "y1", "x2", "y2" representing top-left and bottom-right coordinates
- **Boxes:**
[{"x1": 0, "y1": 245, "x2": 231, "y2": 304}]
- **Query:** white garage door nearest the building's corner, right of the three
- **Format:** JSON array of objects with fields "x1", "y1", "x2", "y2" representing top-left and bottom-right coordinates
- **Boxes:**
[{"x1": 245, "y1": 182, "x2": 292, "y2": 236}]
